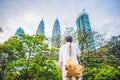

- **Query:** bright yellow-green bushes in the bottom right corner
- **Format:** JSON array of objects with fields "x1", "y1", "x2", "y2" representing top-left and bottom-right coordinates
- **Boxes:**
[{"x1": 84, "y1": 64, "x2": 120, "y2": 80}]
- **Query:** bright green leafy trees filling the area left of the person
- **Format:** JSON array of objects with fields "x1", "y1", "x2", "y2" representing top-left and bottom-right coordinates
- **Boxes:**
[{"x1": 0, "y1": 35, "x2": 61, "y2": 80}]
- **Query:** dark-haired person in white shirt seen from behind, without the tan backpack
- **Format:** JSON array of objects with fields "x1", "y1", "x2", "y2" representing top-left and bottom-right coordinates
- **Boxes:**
[{"x1": 59, "y1": 36, "x2": 81, "y2": 80}]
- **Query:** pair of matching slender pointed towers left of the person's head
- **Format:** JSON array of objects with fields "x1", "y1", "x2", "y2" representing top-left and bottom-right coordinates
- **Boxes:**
[{"x1": 36, "y1": 18, "x2": 61, "y2": 47}]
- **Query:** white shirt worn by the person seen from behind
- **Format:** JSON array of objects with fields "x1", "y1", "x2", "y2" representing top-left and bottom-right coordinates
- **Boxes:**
[{"x1": 59, "y1": 42, "x2": 81, "y2": 70}]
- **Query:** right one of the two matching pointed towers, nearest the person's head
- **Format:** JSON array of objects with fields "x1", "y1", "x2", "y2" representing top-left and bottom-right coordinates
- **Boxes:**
[{"x1": 52, "y1": 19, "x2": 61, "y2": 47}]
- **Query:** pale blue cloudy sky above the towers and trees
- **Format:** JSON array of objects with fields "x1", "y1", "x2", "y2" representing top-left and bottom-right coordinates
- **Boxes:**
[{"x1": 0, "y1": 0, "x2": 120, "y2": 43}]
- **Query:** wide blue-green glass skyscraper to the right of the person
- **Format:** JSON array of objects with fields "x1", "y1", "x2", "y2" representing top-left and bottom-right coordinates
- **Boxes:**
[{"x1": 76, "y1": 11, "x2": 95, "y2": 50}]
